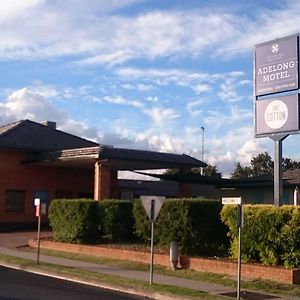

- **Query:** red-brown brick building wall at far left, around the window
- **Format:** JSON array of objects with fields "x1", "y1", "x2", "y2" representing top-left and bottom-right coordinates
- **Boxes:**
[{"x1": 0, "y1": 150, "x2": 94, "y2": 223}]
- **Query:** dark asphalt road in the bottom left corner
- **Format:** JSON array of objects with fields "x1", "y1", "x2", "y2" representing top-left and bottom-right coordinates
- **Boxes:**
[{"x1": 0, "y1": 266, "x2": 149, "y2": 300}]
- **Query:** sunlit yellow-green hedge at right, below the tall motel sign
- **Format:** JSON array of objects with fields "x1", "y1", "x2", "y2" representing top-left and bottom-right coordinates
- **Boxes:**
[{"x1": 221, "y1": 205, "x2": 300, "y2": 267}]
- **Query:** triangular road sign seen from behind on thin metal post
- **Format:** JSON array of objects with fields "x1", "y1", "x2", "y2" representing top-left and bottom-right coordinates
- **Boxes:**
[{"x1": 141, "y1": 196, "x2": 166, "y2": 285}]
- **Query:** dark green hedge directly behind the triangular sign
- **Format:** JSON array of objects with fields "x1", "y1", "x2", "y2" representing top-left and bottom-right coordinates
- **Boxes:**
[{"x1": 133, "y1": 199, "x2": 228, "y2": 255}]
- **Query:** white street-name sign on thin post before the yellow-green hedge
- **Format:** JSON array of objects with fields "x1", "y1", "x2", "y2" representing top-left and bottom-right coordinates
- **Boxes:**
[{"x1": 222, "y1": 197, "x2": 244, "y2": 299}]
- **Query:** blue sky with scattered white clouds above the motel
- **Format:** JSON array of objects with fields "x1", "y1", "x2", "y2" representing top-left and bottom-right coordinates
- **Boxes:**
[{"x1": 0, "y1": 0, "x2": 300, "y2": 177}]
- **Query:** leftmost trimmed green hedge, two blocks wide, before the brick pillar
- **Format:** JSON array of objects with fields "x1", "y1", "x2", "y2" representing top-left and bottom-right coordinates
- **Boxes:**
[{"x1": 49, "y1": 199, "x2": 134, "y2": 244}]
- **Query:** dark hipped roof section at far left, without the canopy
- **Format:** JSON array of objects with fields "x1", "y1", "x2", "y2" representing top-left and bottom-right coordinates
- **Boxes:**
[{"x1": 0, "y1": 120, "x2": 98, "y2": 151}]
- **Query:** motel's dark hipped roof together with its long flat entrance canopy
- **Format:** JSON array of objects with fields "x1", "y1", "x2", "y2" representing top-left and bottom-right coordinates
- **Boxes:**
[{"x1": 0, "y1": 120, "x2": 206, "y2": 170}]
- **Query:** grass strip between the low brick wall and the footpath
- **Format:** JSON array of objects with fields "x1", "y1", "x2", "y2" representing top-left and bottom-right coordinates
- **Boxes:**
[{"x1": 22, "y1": 249, "x2": 300, "y2": 297}]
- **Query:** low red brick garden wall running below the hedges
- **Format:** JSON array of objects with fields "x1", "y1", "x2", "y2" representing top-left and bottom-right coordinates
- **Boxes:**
[{"x1": 28, "y1": 239, "x2": 300, "y2": 284}]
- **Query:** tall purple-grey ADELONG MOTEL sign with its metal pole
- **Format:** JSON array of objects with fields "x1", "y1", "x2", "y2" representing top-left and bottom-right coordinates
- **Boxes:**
[{"x1": 253, "y1": 35, "x2": 300, "y2": 207}]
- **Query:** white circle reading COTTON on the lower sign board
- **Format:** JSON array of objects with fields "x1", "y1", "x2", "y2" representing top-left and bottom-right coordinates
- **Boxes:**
[{"x1": 264, "y1": 100, "x2": 288, "y2": 129}]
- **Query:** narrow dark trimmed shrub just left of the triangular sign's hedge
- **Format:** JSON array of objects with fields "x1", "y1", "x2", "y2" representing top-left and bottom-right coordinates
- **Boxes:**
[{"x1": 99, "y1": 200, "x2": 134, "y2": 242}]
